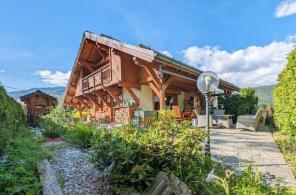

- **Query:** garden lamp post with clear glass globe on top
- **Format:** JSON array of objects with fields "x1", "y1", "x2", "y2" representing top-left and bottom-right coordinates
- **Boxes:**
[{"x1": 197, "y1": 71, "x2": 219, "y2": 158}]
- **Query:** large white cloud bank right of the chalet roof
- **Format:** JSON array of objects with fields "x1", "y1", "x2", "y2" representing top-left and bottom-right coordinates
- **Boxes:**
[{"x1": 182, "y1": 38, "x2": 294, "y2": 87}]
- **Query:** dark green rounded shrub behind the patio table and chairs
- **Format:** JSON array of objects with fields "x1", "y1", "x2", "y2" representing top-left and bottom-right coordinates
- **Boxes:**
[{"x1": 218, "y1": 88, "x2": 258, "y2": 121}]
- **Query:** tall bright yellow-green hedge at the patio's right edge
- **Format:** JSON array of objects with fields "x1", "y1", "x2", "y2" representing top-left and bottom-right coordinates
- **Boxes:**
[{"x1": 274, "y1": 48, "x2": 296, "y2": 136}]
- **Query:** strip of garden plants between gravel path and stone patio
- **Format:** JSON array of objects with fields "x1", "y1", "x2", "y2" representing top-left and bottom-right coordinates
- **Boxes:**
[{"x1": 37, "y1": 109, "x2": 291, "y2": 194}]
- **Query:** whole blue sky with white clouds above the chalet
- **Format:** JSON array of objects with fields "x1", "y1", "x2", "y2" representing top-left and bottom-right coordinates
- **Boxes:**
[{"x1": 0, "y1": 0, "x2": 296, "y2": 91}]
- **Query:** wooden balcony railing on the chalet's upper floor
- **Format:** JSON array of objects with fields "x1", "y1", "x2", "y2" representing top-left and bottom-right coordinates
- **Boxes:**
[{"x1": 82, "y1": 65, "x2": 111, "y2": 92}]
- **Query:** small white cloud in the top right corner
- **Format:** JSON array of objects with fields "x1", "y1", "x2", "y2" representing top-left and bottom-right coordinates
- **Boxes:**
[{"x1": 275, "y1": 0, "x2": 296, "y2": 18}]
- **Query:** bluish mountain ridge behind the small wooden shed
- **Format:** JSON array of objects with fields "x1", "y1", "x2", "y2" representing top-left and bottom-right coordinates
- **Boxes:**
[{"x1": 8, "y1": 87, "x2": 66, "y2": 100}]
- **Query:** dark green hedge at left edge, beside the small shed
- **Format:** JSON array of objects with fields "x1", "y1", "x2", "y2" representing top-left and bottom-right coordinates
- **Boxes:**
[{"x1": 0, "y1": 85, "x2": 26, "y2": 154}]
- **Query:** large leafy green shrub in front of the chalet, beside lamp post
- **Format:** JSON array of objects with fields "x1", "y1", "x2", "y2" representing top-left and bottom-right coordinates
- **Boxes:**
[{"x1": 92, "y1": 110, "x2": 207, "y2": 192}]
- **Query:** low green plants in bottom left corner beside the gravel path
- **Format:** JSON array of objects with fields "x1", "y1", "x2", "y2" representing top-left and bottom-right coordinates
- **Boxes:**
[{"x1": 0, "y1": 129, "x2": 42, "y2": 194}]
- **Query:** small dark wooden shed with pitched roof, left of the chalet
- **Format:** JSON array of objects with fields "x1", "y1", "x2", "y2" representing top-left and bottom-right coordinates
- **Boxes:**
[{"x1": 20, "y1": 90, "x2": 57, "y2": 125}]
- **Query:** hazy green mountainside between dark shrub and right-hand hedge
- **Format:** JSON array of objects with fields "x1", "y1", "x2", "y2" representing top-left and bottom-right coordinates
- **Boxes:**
[{"x1": 254, "y1": 85, "x2": 276, "y2": 105}]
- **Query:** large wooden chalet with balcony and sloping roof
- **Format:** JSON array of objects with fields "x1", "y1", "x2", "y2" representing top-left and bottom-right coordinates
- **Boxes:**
[{"x1": 63, "y1": 32, "x2": 239, "y2": 123}]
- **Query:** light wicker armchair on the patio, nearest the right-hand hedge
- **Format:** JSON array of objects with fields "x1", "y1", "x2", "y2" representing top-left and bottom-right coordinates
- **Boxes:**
[{"x1": 236, "y1": 109, "x2": 263, "y2": 132}]
